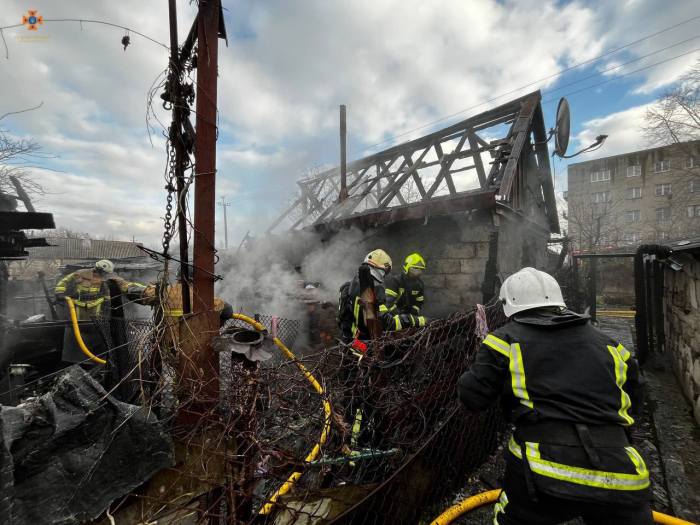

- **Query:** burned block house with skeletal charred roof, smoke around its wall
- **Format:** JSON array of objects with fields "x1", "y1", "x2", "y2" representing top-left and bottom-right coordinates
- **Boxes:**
[{"x1": 256, "y1": 91, "x2": 559, "y2": 342}]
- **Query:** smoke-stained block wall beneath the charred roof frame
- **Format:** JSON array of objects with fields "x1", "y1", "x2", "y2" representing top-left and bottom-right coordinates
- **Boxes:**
[{"x1": 266, "y1": 210, "x2": 548, "y2": 317}]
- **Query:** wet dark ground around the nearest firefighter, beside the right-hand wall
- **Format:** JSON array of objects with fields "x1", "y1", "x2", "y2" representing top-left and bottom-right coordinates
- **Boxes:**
[{"x1": 436, "y1": 317, "x2": 700, "y2": 525}]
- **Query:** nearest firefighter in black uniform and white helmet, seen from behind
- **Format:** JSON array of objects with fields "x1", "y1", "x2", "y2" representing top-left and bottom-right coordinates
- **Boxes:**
[{"x1": 457, "y1": 268, "x2": 653, "y2": 525}]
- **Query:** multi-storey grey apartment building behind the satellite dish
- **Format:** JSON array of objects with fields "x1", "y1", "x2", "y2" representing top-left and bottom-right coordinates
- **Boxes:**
[{"x1": 564, "y1": 140, "x2": 700, "y2": 249}]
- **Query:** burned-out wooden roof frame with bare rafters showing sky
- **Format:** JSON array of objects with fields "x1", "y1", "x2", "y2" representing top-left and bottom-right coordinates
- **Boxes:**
[{"x1": 266, "y1": 91, "x2": 559, "y2": 233}]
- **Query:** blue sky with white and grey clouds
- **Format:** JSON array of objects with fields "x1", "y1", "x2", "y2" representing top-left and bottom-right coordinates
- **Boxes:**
[{"x1": 0, "y1": 0, "x2": 700, "y2": 246}]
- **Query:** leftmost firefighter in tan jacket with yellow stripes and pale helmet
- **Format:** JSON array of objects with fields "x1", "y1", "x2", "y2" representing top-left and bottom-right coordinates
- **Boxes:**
[{"x1": 55, "y1": 259, "x2": 114, "y2": 321}]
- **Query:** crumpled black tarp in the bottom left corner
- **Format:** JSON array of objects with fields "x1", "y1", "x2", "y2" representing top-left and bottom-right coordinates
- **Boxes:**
[{"x1": 0, "y1": 366, "x2": 175, "y2": 525}]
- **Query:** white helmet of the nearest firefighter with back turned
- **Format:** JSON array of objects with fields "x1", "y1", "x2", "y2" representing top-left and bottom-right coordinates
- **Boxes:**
[{"x1": 498, "y1": 268, "x2": 566, "y2": 317}]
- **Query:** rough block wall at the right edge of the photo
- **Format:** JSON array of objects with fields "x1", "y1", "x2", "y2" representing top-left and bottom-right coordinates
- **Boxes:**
[{"x1": 664, "y1": 254, "x2": 700, "y2": 423}]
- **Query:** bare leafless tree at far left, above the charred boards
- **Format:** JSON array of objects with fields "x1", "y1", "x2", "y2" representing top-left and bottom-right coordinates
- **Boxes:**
[{"x1": 0, "y1": 105, "x2": 55, "y2": 208}]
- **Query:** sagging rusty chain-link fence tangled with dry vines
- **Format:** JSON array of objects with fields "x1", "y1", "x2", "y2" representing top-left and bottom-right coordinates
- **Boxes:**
[{"x1": 89, "y1": 304, "x2": 507, "y2": 524}]
